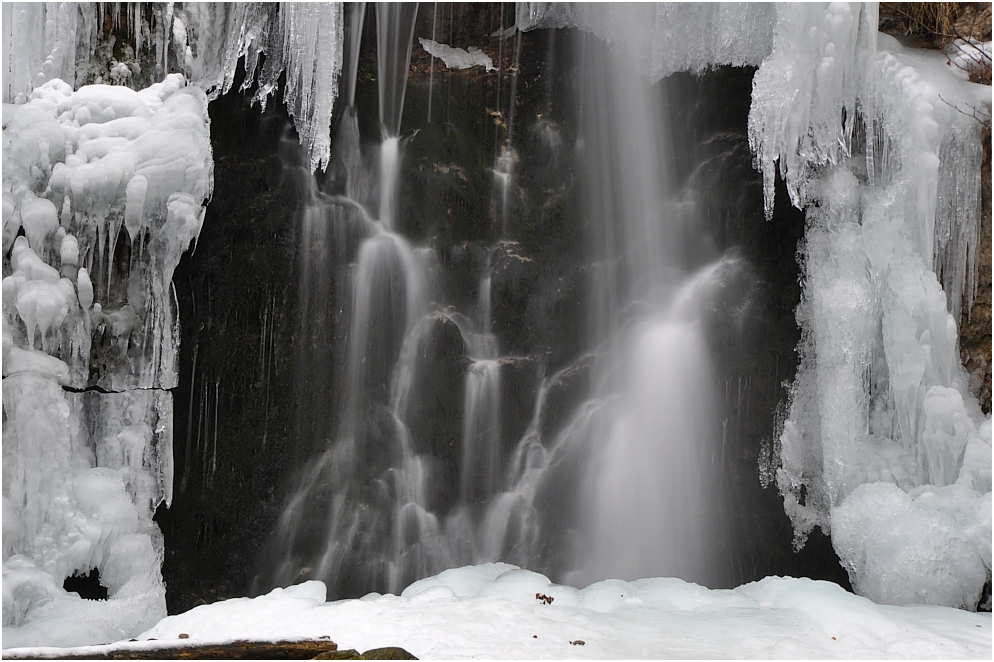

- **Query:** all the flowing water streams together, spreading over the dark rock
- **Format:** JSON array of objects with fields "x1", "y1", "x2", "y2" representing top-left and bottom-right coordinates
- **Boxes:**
[{"x1": 257, "y1": 5, "x2": 736, "y2": 593}]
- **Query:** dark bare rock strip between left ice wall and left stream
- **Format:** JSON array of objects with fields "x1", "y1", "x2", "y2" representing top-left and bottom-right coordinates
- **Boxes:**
[{"x1": 156, "y1": 66, "x2": 297, "y2": 613}]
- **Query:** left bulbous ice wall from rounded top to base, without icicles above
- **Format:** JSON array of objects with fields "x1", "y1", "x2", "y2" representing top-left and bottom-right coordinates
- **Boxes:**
[{"x1": 3, "y1": 74, "x2": 213, "y2": 647}]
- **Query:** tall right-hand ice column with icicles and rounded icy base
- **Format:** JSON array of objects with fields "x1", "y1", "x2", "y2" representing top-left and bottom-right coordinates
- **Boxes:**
[{"x1": 749, "y1": 4, "x2": 991, "y2": 609}]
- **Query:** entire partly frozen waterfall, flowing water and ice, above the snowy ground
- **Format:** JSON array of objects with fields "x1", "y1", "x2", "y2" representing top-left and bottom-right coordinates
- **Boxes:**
[{"x1": 3, "y1": 3, "x2": 991, "y2": 644}]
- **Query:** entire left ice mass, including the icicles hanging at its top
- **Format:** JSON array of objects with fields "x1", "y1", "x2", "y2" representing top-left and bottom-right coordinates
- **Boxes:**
[{"x1": 3, "y1": 3, "x2": 342, "y2": 647}]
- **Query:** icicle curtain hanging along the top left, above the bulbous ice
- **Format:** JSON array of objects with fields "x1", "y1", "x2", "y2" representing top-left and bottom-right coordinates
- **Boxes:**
[{"x1": 3, "y1": 2, "x2": 344, "y2": 170}]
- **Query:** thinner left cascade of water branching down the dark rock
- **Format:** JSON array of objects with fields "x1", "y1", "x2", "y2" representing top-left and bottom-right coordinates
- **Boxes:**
[{"x1": 254, "y1": 5, "x2": 448, "y2": 591}]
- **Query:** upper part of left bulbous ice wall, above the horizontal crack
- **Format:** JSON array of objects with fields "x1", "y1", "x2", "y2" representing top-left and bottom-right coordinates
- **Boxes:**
[{"x1": 3, "y1": 74, "x2": 213, "y2": 391}]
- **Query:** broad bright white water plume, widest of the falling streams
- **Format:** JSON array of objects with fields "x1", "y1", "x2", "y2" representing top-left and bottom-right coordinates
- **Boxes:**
[{"x1": 516, "y1": 19, "x2": 735, "y2": 585}]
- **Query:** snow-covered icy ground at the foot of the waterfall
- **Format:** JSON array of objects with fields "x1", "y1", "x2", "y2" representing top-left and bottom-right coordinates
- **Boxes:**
[{"x1": 4, "y1": 563, "x2": 991, "y2": 659}]
